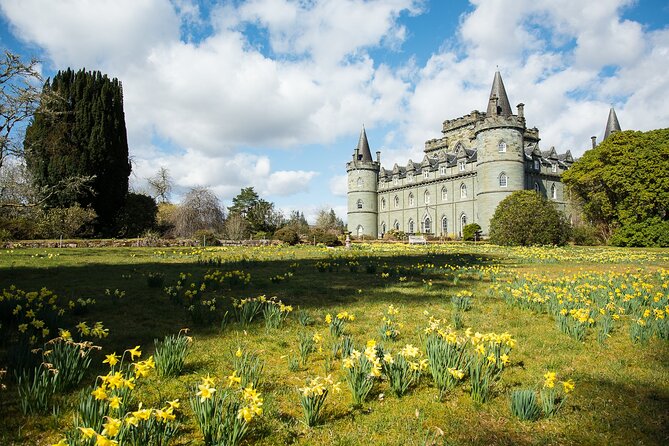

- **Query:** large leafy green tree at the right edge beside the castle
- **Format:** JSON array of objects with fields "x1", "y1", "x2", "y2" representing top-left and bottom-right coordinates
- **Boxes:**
[{"x1": 563, "y1": 129, "x2": 669, "y2": 246}]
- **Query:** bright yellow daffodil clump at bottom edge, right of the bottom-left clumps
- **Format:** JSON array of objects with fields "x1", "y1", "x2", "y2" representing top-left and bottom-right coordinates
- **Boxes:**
[{"x1": 190, "y1": 373, "x2": 263, "y2": 446}]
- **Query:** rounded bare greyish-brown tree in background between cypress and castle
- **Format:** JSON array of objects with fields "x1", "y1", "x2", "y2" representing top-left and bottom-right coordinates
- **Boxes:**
[{"x1": 175, "y1": 187, "x2": 225, "y2": 237}]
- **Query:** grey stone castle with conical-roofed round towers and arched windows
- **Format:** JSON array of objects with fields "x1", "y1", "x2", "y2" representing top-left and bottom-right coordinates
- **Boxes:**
[{"x1": 346, "y1": 71, "x2": 620, "y2": 238}]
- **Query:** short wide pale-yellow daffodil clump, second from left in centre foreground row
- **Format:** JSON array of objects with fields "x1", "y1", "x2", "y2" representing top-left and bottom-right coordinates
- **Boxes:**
[{"x1": 382, "y1": 344, "x2": 428, "y2": 397}]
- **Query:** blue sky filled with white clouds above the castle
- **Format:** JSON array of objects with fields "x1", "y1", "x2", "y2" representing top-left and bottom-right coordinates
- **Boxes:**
[{"x1": 0, "y1": 0, "x2": 669, "y2": 222}]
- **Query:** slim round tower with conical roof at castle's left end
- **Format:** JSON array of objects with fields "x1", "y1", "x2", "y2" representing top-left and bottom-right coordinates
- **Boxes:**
[{"x1": 346, "y1": 127, "x2": 381, "y2": 239}]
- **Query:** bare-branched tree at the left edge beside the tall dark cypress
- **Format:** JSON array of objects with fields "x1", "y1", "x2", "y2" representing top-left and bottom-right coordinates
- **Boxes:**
[{"x1": 0, "y1": 51, "x2": 42, "y2": 169}]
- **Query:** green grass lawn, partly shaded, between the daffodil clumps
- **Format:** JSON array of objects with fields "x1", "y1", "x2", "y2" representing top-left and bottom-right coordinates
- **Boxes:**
[{"x1": 0, "y1": 244, "x2": 669, "y2": 445}]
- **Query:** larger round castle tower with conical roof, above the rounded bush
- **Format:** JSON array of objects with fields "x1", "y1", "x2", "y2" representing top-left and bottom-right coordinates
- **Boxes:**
[{"x1": 475, "y1": 71, "x2": 525, "y2": 234}]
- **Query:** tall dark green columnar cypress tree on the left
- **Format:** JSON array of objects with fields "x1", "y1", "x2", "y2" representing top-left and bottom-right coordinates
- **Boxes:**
[{"x1": 24, "y1": 68, "x2": 131, "y2": 234}]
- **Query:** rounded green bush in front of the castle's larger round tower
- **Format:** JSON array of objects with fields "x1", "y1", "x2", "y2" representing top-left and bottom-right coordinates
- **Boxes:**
[{"x1": 490, "y1": 190, "x2": 569, "y2": 246}]
